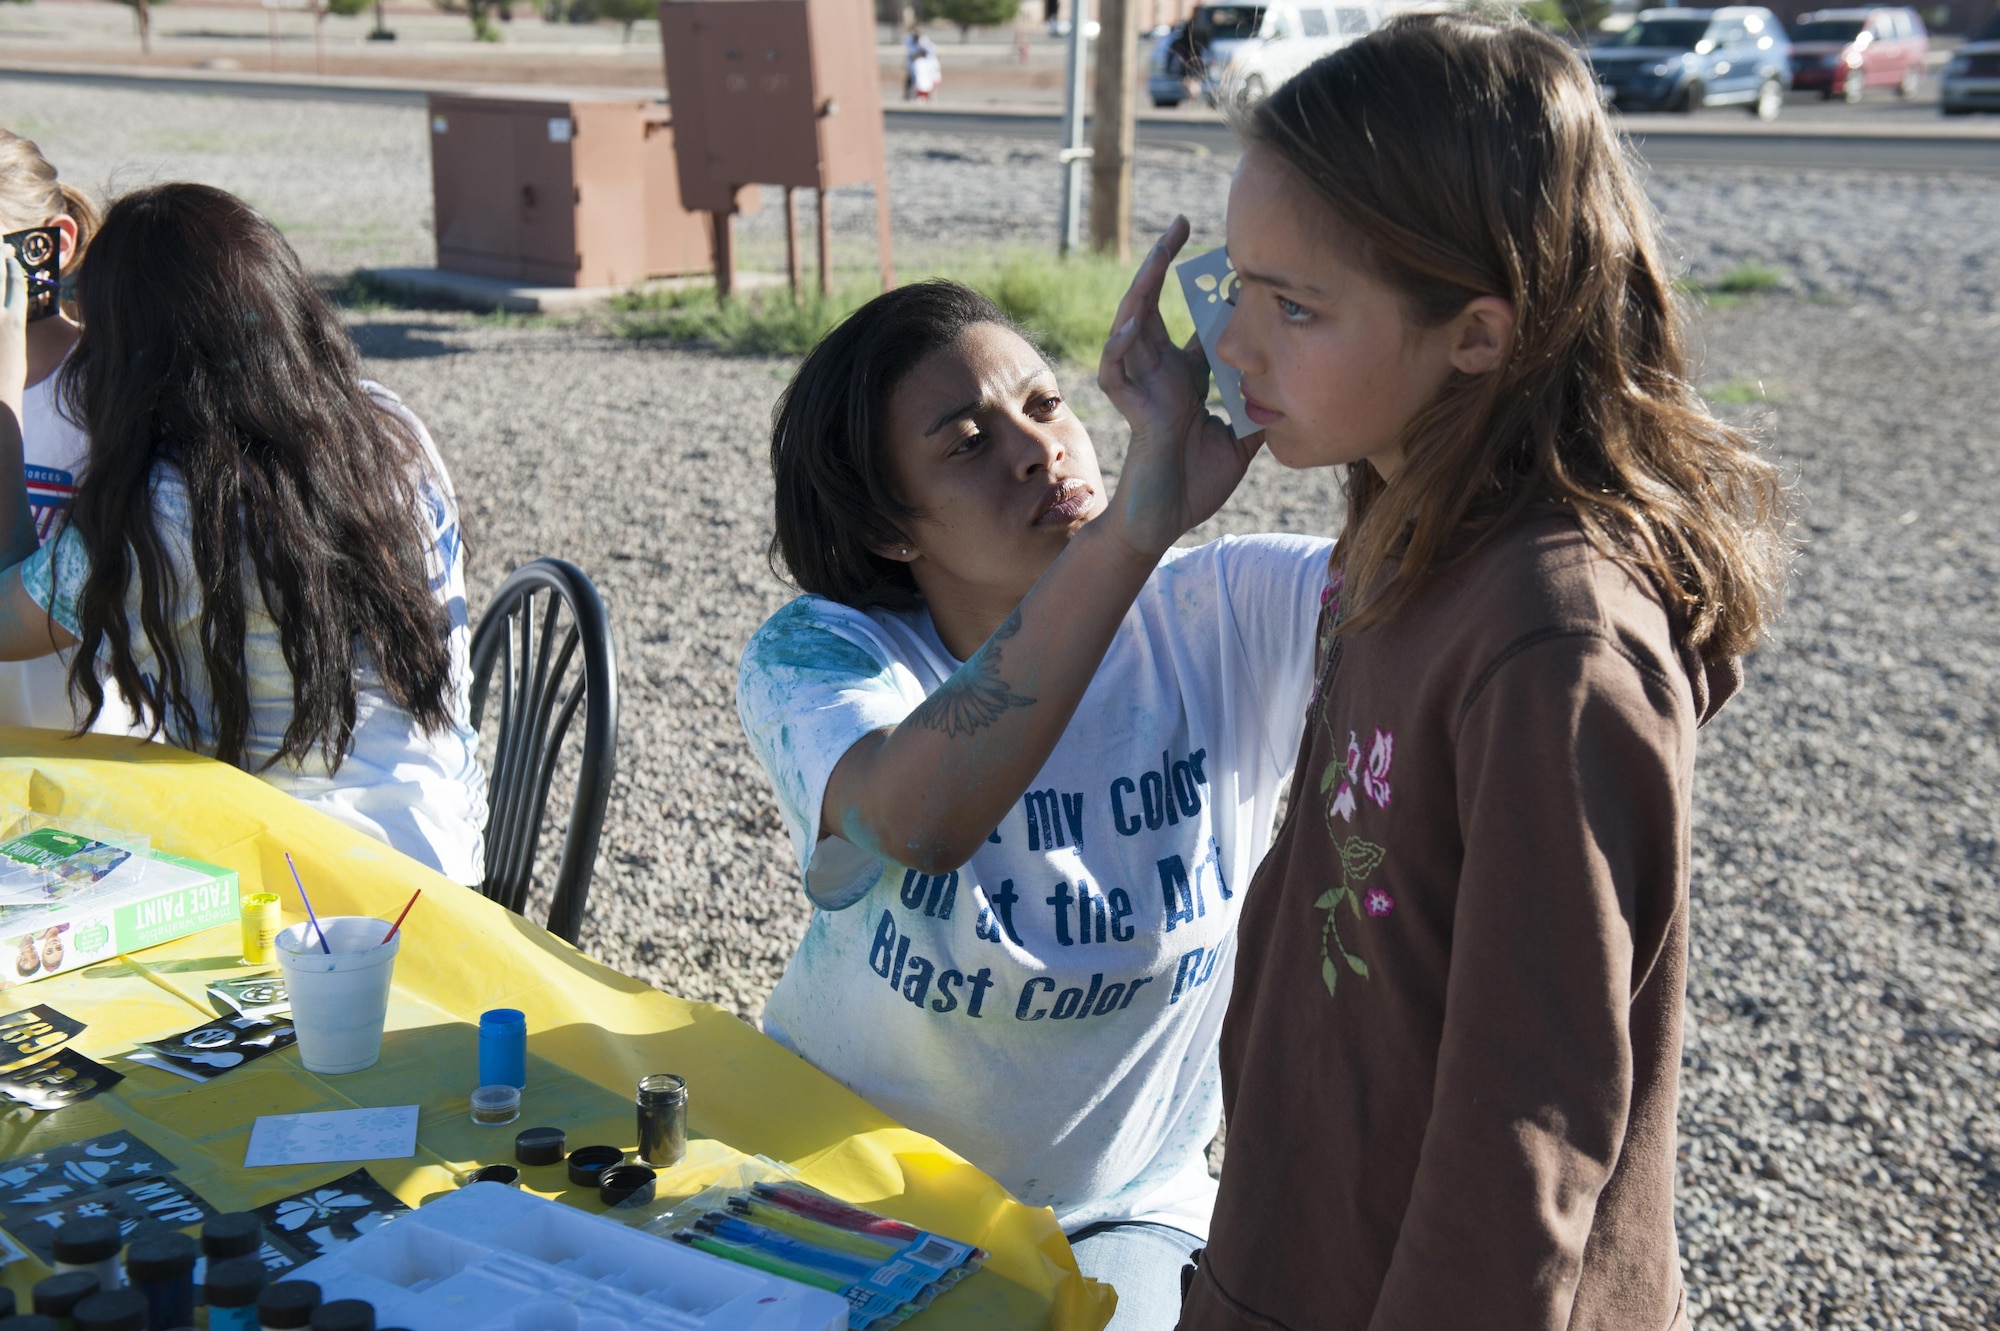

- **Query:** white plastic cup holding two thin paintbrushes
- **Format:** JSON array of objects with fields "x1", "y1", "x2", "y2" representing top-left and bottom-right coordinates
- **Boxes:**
[{"x1": 276, "y1": 915, "x2": 402, "y2": 1073}]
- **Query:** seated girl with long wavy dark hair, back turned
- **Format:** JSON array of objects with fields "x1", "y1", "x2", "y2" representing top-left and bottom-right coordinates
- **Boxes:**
[{"x1": 0, "y1": 184, "x2": 486, "y2": 883}]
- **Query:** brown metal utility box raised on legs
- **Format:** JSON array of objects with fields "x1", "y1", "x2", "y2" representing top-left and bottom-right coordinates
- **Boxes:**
[{"x1": 660, "y1": 0, "x2": 890, "y2": 290}]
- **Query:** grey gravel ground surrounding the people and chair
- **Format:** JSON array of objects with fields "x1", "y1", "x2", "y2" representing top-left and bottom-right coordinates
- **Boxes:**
[{"x1": 0, "y1": 80, "x2": 2000, "y2": 1329}]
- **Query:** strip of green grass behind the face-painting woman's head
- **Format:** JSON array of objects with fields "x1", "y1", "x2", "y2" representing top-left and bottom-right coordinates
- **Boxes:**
[{"x1": 608, "y1": 252, "x2": 1194, "y2": 364}]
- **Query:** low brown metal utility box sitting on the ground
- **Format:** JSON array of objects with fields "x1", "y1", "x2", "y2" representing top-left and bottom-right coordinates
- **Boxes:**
[{"x1": 430, "y1": 94, "x2": 712, "y2": 286}]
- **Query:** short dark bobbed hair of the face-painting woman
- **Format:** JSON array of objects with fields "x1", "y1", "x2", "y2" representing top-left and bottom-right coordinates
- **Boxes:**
[{"x1": 768, "y1": 282, "x2": 1014, "y2": 610}]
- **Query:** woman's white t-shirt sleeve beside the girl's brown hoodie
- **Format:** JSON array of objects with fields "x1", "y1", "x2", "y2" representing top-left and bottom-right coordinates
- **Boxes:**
[{"x1": 1212, "y1": 534, "x2": 1334, "y2": 773}]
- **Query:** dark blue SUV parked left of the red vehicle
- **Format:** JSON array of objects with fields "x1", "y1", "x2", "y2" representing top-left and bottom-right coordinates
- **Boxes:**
[{"x1": 1588, "y1": 4, "x2": 1792, "y2": 120}]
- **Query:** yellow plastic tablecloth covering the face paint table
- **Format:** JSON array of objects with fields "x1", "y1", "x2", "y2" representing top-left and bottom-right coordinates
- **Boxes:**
[{"x1": 0, "y1": 727, "x2": 1114, "y2": 1331}]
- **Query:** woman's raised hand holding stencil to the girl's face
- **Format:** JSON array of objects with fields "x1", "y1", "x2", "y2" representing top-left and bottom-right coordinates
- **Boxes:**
[{"x1": 1098, "y1": 218, "x2": 1264, "y2": 556}]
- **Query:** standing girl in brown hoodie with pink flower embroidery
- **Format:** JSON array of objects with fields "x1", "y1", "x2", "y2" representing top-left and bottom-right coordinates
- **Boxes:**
[{"x1": 1100, "y1": 14, "x2": 1786, "y2": 1331}]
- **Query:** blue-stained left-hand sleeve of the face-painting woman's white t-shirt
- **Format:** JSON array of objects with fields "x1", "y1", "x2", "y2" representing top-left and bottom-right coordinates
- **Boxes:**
[{"x1": 736, "y1": 596, "x2": 924, "y2": 909}]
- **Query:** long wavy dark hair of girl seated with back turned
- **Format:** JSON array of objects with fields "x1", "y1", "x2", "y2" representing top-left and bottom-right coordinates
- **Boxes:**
[{"x1": 60, "y1": 184, "x2": 450, "y2": 767}]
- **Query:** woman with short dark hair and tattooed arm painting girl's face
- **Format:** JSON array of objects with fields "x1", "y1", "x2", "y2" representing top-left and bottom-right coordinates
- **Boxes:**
[{"x1": 738, "y1": 279, "x2": 1330, "y2": 1327}]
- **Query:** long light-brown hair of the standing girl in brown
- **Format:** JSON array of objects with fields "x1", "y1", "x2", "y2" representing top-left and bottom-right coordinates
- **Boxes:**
[{"x1": 1242, "y1": 14, "x2": 1790, "y2": 660}]
